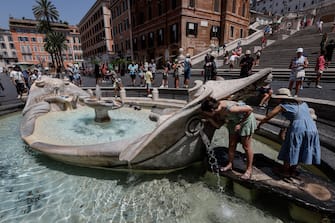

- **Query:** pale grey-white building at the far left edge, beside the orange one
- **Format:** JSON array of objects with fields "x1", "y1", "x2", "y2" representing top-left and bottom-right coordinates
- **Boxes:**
[{"x1": 0, "y1": 29, "x2": 18, "y2": 70}]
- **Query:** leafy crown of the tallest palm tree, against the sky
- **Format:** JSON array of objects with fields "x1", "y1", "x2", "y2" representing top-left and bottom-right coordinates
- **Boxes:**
[{"x1": 33, "y1": 0, "x2": 59, "y2": 33}]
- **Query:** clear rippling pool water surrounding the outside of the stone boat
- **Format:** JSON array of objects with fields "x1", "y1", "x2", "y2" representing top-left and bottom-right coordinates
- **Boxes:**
[{"x1": 0, "y1": 113, "x2": 288, "y2": 223}]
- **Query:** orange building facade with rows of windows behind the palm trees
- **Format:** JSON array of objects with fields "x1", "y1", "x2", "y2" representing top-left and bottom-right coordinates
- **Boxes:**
[{"x1": 9, "y1": 17, "x2": 82, "y2": 67}]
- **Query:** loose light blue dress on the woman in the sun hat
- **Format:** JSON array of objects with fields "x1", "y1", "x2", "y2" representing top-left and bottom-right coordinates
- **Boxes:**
[{"x1": 278, "y1": 102, "x2": 321, "y2": 165}]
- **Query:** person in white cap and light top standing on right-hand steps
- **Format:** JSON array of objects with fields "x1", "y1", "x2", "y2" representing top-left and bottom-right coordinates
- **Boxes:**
[{"x1": 288, "y1": 48, "x2": 308, "y2": 97}]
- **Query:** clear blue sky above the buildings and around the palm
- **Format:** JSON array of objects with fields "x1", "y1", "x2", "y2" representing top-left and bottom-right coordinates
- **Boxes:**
[{"x1": 0, "y1": 0, "x2": 96, "y2": 29}]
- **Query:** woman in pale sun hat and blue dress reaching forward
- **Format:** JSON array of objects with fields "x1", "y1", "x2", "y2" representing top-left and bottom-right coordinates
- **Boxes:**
[{"x1": 257, "y1": 88, "x2": 321, "y2": 176}]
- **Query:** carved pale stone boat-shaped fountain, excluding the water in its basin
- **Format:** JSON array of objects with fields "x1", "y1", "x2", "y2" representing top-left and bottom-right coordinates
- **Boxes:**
[{"x1": 21, "y1": 69, "x2": 271, "y2": 171}]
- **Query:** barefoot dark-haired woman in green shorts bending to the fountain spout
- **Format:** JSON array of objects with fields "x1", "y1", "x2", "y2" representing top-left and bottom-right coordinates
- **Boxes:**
[{"x1": 201, "y1": 98, "x2": 257, "y2": 179}]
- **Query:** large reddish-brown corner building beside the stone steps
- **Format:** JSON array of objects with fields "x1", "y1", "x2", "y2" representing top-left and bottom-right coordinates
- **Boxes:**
[{"x1": 111, "y1": 0, "x2": 250, "y2": 62}]
